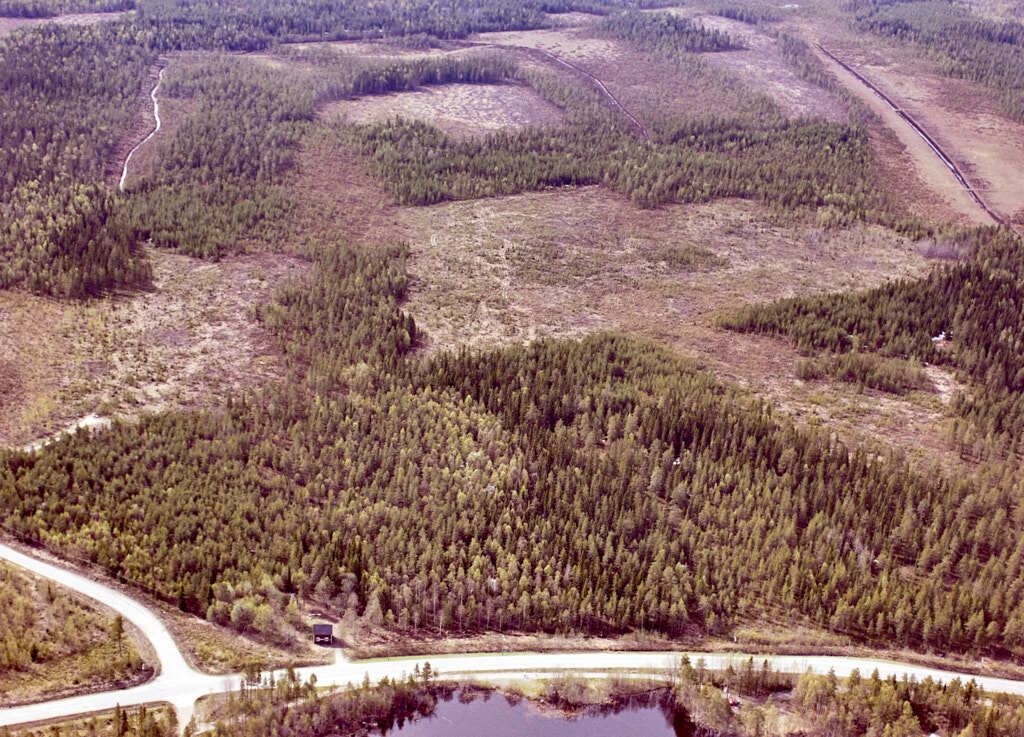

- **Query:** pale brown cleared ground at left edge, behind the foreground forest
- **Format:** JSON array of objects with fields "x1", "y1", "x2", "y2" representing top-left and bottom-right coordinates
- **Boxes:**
[{"x1": 0, "y1": 251, "x2": 308, "y2": 445}]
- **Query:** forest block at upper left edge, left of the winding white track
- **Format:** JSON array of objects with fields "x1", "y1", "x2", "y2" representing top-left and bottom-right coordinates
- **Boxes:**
[{"x1": 0, "y1": 26, "x2": 152, "y2": 297}]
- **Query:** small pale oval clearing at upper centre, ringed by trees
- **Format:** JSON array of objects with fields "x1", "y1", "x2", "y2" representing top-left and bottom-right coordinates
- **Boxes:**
[{"x1": 322, "y1": 84, "x2": 562, "y2": 138}]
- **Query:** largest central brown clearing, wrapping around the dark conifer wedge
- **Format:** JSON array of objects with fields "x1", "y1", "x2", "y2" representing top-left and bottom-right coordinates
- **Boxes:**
[{"x1": 401, "y1": 187, "x2": 961, "y2": 466}]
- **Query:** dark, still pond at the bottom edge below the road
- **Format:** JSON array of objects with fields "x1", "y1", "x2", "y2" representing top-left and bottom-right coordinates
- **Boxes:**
[{"x1": 381, "y1": 691, "x2": 700, "y2": 737}]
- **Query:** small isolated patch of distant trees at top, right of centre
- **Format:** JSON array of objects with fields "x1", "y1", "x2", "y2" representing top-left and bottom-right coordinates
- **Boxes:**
[{"x1": 597, "y1": 10, "x2": 742, "y2": 56}]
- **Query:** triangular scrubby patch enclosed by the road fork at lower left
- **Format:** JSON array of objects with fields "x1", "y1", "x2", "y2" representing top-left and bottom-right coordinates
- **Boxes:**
[{"x1": 0, "y1": 564, "x2": 141, "y2": 700}]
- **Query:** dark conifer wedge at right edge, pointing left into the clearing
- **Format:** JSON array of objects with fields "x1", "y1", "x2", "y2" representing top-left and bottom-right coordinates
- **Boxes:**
[{"x1": 721, "y1": 228, "x2": 1024, "y2": 456}]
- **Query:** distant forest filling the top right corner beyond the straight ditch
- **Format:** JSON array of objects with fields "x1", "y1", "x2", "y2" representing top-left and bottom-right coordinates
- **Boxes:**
[{"x1": 848, "y1": 0, "x2": 1024, "y2": 121}]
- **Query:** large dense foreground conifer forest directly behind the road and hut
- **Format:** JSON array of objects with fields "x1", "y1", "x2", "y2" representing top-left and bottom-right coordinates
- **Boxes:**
[{"x1": 0, "y1": 217, "x2": 1024, "y2": 653}]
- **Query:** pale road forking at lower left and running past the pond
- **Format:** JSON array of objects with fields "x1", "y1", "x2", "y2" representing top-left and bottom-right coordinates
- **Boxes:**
[{"x1": 0, "y1": 545, "x2": 1024, "y2": 727}]
